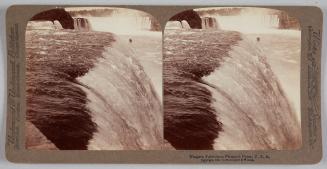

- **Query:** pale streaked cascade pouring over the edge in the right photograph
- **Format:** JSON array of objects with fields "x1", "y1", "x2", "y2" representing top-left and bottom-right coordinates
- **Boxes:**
[{"x1": 202, "y1": 37, "x2": 301, "y2": 150}]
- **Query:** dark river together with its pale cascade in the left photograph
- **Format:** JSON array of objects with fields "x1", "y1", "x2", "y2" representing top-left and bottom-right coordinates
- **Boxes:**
[{"x1": 26, "y1": 30, "x2": 163, "y2": 150}]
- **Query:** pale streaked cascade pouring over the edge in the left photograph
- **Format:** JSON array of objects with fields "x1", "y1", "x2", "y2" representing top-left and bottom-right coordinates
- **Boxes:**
[{"x1": 77, "y1": 38, "x2": 163, "y2": 150}]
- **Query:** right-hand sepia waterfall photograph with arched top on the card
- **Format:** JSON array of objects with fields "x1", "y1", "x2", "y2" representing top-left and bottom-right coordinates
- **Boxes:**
[{"x1": 163, "y1": 7, "x2": 302, "y2": 150}]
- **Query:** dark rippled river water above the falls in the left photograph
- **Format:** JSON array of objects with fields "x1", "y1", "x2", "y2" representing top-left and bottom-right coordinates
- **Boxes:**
[{"x1": 26, "y1": 30, "x2": 114, "y2": 149}]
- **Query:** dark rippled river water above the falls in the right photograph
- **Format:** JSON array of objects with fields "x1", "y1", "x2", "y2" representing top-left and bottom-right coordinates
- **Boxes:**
[{"x1": 163, "y1": 30, "x2": 240, "y2": 149}]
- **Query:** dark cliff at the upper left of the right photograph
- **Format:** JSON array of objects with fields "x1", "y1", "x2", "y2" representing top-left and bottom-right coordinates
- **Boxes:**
[{"x1": 169, "y1": 10, "x2": 202, "y2": 29}]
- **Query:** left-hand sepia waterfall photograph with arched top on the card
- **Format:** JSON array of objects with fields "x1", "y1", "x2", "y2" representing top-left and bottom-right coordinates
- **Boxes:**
[{"x1": 25, "y1": 7, "x2": 163, "y2": 150}]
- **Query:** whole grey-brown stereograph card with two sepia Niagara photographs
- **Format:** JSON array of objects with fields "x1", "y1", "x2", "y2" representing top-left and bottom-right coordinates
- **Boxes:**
[{"x1": 6, "y1": 4, "x2": 322, "y2": 164}]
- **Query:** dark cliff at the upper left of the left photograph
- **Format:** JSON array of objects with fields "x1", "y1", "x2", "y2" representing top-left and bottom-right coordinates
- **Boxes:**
[{"x1": 30, "y1": 9, "x2": 74, "y2": 29}]
